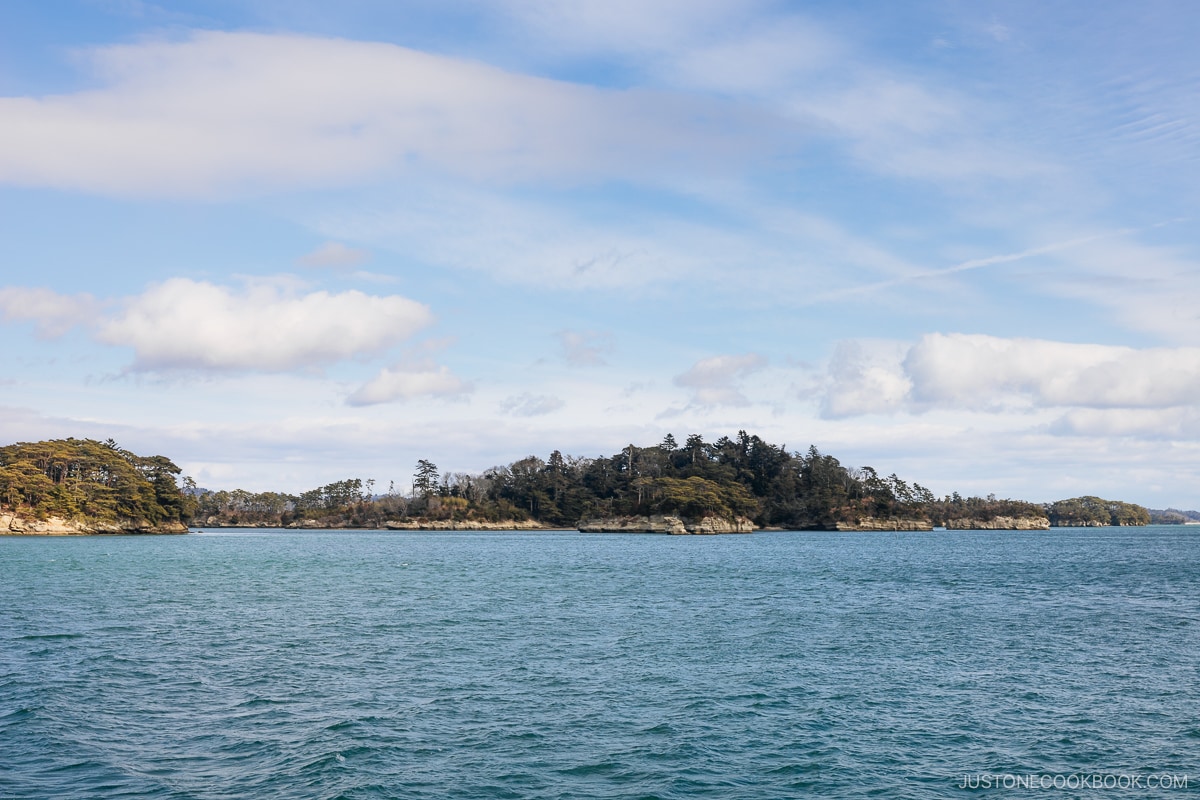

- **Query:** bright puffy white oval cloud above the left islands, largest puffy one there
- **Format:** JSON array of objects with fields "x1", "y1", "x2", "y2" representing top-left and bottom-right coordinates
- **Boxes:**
[{"x1": 96, "y1": 278, "x2": 433, "y2": 372}]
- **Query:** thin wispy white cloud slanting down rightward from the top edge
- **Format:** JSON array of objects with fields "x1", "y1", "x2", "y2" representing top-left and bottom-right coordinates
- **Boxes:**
[{"x1": 496, "y1": 0, "x2": 1050, "y2": 185}]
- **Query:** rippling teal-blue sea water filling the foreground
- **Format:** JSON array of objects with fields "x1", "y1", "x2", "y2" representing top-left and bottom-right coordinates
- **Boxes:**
[{"x1": 0, "y1": 527, "x2": 1200, "y2": 800}]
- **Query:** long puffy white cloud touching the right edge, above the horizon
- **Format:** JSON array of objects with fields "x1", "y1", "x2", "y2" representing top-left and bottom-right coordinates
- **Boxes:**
[{"x1": 822, "y1": 333, "x2": 1200, "y2": 419}]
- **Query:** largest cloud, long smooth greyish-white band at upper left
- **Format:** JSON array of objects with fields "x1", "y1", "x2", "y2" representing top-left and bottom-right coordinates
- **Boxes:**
[{"x1": 0, "y1": 31, "x2": 762, "y2": 196}]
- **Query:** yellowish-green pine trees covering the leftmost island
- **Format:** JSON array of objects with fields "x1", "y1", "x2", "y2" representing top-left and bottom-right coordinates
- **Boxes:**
[{"x1": 0, "y1": 439, "x2": 194, "y2": 525}]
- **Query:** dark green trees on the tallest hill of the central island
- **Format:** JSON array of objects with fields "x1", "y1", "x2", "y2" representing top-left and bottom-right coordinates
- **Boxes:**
[{"x1": 408, "y1": 431, "x2": 932, "y2": 528}]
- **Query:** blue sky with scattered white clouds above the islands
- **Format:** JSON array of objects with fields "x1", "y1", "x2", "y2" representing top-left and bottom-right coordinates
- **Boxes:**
[{"x1": 0, "y1": 0, "x2": 1200, "y2": 509}]
